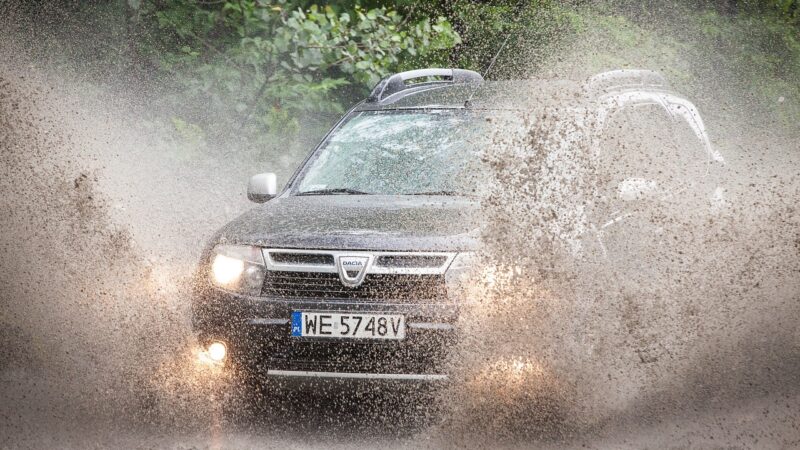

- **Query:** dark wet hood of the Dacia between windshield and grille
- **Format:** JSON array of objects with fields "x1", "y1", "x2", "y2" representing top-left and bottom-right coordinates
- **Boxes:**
[{"x1": 215, "y1": 195, "x2": 479, "y2": 251}]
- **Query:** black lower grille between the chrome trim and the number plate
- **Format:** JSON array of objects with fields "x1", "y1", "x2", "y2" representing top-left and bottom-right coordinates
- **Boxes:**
[{"x1": 262, "y1": 270, "x2": 447, "y2": 303}]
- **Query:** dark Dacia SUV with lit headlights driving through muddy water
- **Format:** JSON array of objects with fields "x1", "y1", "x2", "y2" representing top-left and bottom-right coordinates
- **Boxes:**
[{"x1": 193, "y1": 69, "x2": 721, "y2": 381}]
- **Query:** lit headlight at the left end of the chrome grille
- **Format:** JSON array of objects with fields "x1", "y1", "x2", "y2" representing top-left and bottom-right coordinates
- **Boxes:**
[{"x1": 211, "y1": 245, "x2": 267, "y2": 295}]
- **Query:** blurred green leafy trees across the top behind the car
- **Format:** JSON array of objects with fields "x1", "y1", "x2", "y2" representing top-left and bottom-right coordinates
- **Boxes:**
[{"x1": 4, "y1": 0, "x2": 800, "y2": 166}]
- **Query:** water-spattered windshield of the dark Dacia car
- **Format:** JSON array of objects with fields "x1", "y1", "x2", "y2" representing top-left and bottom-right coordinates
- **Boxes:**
[{"x1": 296, "y1": 110, "x2": 482, "y2": 195}]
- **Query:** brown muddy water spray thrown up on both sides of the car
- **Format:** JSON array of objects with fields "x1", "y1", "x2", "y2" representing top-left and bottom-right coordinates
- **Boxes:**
[{"x1": 0, "y1": 1, "x2": 800, "y2": 448}]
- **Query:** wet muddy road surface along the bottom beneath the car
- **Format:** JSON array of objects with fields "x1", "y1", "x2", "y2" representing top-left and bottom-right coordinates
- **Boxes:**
[{"x1": 0, "y1": 370, "x2": 800, "y2": 449}]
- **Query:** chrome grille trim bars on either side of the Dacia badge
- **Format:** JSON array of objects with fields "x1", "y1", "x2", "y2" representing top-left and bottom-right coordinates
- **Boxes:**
[{"x1": 262, "y1": 248, "x2": 456, "y2": 275}]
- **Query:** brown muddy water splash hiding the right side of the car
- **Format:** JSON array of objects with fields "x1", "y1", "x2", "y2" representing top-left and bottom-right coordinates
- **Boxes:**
[{"x1": 434, "y1": 80, "x2": 800, "y2": 446}]
